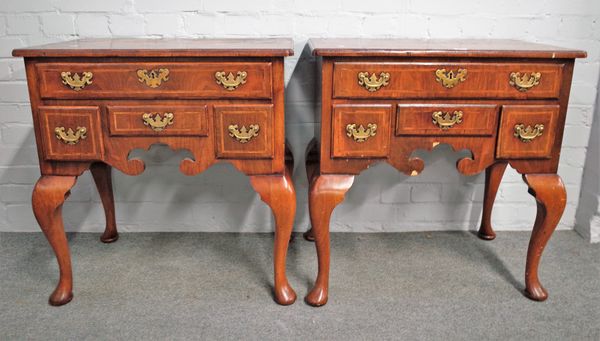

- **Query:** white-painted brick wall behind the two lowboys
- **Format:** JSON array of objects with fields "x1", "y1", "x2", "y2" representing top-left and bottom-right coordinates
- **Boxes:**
[{"x1": 0, "y1": 0, "x2": 600, "y2": 236}]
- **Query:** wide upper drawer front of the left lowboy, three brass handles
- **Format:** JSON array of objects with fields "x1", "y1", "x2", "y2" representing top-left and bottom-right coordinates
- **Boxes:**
[{"x1": 37, "y1": 62, "x2": 272, "y2": 99}]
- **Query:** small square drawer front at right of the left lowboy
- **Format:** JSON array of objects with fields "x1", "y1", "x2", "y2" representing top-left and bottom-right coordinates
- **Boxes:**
[{"x1": 214, "y1": 104, "x2": 274, "y2": 159}]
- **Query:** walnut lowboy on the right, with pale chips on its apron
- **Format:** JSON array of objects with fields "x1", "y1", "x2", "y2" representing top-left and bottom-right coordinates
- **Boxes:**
[{"x1": 305, "y1": 39, "x2": 585, "y2": 306}]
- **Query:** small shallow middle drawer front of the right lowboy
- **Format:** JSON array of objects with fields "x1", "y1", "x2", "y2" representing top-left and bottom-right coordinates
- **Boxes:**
[{"x1": 396, "y1": 104, "x2": 498, "y2": 136}]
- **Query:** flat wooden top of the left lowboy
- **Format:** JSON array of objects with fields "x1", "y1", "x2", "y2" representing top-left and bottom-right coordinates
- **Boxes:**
[{"x1": 13, "y1": 38, "x2": 294, "y2": 57}]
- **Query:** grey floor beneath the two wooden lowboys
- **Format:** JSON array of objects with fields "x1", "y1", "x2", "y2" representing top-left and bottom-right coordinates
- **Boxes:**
[{"x1": 0, "y1": 231, "x2": 600, "y2": 340}]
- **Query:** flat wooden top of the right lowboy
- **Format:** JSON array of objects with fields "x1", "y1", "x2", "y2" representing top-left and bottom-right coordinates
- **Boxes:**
[{"x1": 309, "y1": 38, "x2": 587, "y2": 59}]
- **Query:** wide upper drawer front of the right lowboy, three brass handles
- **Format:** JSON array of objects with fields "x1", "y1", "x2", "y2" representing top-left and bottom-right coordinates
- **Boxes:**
[{"x1": 333, "y1": 62, "x2": 563, "y2": 99}]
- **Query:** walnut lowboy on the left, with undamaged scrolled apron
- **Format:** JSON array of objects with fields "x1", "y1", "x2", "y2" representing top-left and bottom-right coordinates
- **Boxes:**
[{"x1": 13, "y1": 39, "x2": 296, "y2": 305}]
